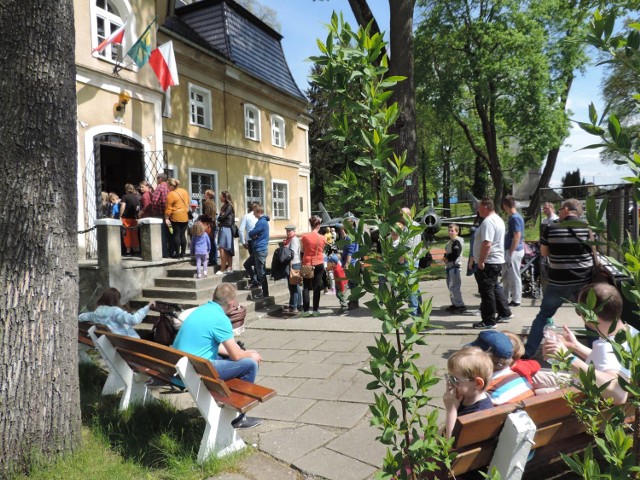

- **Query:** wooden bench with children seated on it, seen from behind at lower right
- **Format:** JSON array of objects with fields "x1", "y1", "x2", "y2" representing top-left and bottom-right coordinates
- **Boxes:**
[{"x1": 442, "y1": 390, "x2": 628, "y2": 479}]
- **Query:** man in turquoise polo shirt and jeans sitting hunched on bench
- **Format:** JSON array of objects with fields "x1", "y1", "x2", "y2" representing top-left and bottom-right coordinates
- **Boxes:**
[{"x1": 172, "y1": 283, "x2": 262, "y2": 428}]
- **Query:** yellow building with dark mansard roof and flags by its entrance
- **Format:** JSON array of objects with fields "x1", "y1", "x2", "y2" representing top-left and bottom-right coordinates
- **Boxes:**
[{"x1": 75, "y1": 0, "x2": 311, "y2": 258}]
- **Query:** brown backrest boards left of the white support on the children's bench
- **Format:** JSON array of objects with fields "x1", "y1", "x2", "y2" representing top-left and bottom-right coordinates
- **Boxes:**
[{"x1": 453, "y1": 404, "x2": 517, "y2": 450}]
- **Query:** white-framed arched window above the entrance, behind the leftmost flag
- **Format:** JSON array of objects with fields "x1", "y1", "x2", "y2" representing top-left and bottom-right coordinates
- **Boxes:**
[{"x1": 92, "y1": 0, "x2": 134, "y2": 62}]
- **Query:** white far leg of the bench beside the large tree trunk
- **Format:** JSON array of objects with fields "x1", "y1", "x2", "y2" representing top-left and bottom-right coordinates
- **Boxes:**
[{"x1": 89, "y1": 327, "x2": 151, "y2": 410}]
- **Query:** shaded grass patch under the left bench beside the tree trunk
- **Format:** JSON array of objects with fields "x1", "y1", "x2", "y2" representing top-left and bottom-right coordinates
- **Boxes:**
[{"x1": 11, "y1": 364, "x2": 250, "y2": 480}]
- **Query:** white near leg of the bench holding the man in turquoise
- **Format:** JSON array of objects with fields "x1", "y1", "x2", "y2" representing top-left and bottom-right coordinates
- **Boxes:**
[{"x1": 176, "y1": 357, "x2": 245, "y2": 463}]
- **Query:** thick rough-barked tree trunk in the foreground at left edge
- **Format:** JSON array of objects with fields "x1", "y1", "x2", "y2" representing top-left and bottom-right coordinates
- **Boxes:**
[{"x1": 0, "y1": 0, "x2": 80, "y2": 477}]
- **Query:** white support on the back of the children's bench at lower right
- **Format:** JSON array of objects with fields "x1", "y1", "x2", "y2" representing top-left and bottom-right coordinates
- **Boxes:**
[{"x1": 489, "y1": 410, "x2": 536, "y2": 480}]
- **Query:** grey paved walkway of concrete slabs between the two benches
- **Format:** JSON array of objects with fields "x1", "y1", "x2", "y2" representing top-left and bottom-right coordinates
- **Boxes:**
[{"x1": 188, "y1": 277, "x2": 582, "y2": 480}]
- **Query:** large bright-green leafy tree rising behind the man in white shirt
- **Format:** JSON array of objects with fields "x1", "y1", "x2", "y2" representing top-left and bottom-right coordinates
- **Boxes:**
[{"x1": 416, "y1": 0, "x2": 568, "y2": 208}]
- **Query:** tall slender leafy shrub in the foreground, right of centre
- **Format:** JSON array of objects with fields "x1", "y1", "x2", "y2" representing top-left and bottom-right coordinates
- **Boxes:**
[{"x1": 312, "y1": 13, "x2": 452, "y2": 479}]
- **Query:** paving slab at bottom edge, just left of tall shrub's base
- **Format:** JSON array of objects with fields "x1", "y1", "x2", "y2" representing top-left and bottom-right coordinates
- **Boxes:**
[{"x1": 294, "y1": 448, "x2": 376, "y2": 480}]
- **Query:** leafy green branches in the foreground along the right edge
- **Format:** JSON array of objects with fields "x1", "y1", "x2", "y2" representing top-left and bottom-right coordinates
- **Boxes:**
[{"x1": 565, "y1": 12, "x2": 640, "y2": 480}]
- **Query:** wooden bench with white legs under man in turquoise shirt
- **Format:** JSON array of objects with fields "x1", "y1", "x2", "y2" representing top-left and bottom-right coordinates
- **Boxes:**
[{"x1": 88, "y1": 326, "x2": 276, "y2": 463}]
